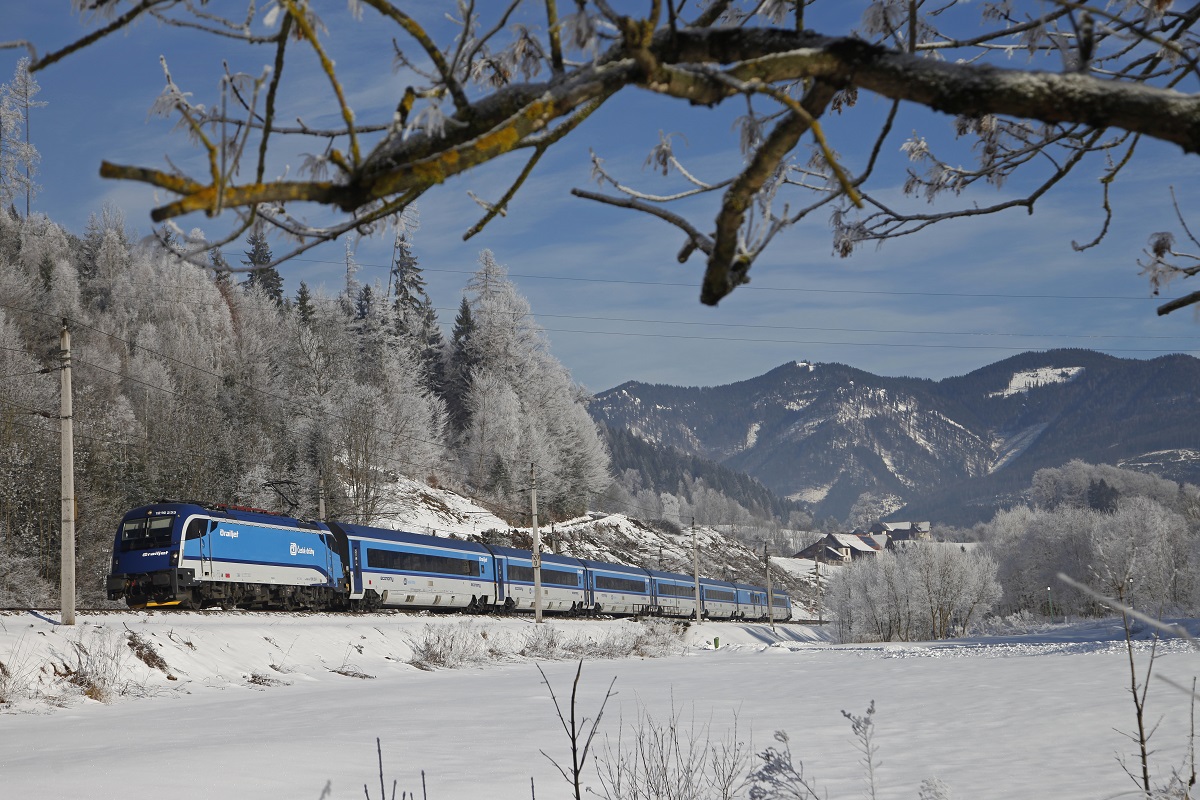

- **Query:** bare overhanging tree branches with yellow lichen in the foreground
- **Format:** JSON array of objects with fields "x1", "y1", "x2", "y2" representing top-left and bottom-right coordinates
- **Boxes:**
[{"x1": 10, "y1": 0, "x2": 1200, "y2": 311}]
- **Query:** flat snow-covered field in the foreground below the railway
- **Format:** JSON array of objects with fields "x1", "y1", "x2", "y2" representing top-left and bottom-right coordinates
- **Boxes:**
[{"x1": 0, "y1": 612, "x2": 1200, "y2": 800}]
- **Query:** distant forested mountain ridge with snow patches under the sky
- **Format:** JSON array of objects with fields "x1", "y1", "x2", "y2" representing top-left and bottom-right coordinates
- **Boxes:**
[{"x1": 589, "y1": 349, "x2": 1200, "y2": 524}]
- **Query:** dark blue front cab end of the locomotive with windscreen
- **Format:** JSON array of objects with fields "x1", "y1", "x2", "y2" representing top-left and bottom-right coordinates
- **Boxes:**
[{"x1": 107, "y1": 504, "x2": 196, "y2": 607}]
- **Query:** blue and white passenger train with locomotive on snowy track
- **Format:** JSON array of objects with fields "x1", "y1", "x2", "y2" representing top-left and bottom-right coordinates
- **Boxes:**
[{"x1": 106, "y1": 501, "x2": 792, "y2": 621}]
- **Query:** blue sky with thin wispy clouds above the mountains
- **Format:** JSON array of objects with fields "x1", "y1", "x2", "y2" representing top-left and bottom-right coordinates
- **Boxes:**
[{"x1": 7, "y1": 0, "x2": 1200, "y2": 391}]
